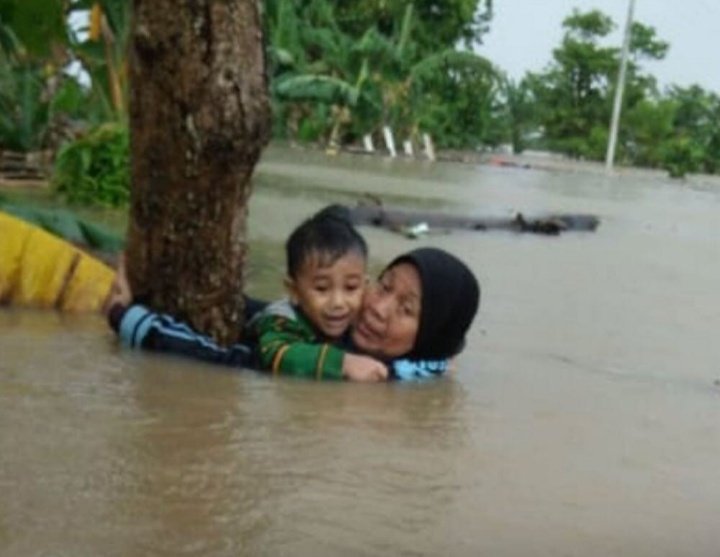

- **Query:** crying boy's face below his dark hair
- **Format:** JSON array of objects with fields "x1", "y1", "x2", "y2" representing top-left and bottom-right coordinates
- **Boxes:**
[{"x1": 285, "y1": 252, "x2": 366, "y2": 338}]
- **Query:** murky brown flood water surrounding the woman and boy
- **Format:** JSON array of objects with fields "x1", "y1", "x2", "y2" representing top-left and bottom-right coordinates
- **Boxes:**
[{"x1": 0, "y1": 148, "x2": 720, "y2": 557}]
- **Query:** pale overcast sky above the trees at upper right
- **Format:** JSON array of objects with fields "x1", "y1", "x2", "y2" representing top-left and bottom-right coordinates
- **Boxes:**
[{"x1": 476, "y1": 0, "x2": 720, "y2": 93}]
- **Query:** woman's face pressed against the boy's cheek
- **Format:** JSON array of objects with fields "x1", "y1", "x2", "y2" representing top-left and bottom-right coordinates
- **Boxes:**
[{"x1": 352, "y1": 263, "x2": 422, "y2": 358}]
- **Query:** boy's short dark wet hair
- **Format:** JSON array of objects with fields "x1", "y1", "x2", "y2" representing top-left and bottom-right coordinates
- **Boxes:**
[{"x1": 285, "y1": 205, "x2": 367, "y2": 279}]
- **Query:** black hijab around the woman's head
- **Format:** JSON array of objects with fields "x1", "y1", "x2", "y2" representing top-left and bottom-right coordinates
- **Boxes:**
[{"x1": 387, "y1": 248, "x2": 480, "y2": 359}]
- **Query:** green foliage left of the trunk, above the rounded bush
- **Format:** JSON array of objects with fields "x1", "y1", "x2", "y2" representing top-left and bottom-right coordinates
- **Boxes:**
[{"x1": 0, "y1": 0, "x2": 123, "y2": 151}]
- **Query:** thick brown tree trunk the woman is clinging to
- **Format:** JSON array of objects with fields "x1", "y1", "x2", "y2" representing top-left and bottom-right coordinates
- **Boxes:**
[{"x1": 127, "y1": 0, "x2": 269, "y2": 344}]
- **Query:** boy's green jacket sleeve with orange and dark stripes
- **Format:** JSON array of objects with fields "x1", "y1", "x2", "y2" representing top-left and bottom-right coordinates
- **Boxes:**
[{"x1": 255, "y1": 315, "x2": 345, "y2": 379}]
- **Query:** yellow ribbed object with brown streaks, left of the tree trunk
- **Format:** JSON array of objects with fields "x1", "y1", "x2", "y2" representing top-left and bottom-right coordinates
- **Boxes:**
[{"x1": 0, "y1": 212, "x2": 114, "y2": 311}]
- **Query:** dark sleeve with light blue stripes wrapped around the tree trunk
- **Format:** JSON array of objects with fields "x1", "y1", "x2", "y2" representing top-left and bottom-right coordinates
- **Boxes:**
[{"x1": 108, "y1": 305, "x2": 255, "y2": 367}]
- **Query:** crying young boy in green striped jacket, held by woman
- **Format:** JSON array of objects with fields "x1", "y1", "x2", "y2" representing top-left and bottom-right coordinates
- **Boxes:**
[{"x1": 249, "y1": 205, "x2": 387, "y2": 380}]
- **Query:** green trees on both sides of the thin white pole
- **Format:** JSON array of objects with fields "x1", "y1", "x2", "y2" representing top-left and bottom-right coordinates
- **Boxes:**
[{"x1": 506, "y1": 10, "x2": 720, "y2": 177}]
